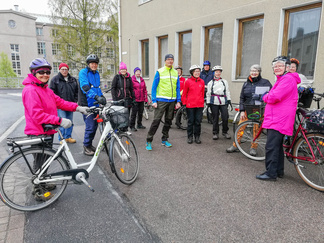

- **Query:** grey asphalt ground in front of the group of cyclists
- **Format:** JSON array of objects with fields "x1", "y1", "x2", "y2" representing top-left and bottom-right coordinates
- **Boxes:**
[{"x1": 0, "y1": 89, "x2": 324, "y2": 243}]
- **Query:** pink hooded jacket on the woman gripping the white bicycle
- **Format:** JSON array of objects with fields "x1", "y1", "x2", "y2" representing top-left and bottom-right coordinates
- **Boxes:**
[{"x1": 22, "y1": 74, "x2": 78, "y2": 135}]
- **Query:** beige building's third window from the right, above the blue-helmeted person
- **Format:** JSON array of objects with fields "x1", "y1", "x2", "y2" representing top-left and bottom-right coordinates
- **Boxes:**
[{"x1": 204, "y1": 24, "x2": 223, "y2": 66}]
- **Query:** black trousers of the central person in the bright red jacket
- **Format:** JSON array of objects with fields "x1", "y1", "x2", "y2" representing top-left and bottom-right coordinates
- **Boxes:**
[{"x1": 186, "y1": 107, "x2": 204, "y2": 138}]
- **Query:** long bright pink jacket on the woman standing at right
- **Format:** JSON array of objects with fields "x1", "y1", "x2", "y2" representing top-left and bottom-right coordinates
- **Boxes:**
[{"x1": 262, "y1": 73, "x2": 300, "y2": 136}]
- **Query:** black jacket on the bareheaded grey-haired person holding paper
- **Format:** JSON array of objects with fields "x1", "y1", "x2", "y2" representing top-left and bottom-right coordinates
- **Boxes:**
[{"x1": 240, "y1": 75, "x2": 272, "y2": 111}]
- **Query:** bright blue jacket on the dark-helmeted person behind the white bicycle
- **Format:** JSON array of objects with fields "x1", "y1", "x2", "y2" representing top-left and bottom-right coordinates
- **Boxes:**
[{"x1": 79, "y1": 67, "x2": 102, "y2": 107}]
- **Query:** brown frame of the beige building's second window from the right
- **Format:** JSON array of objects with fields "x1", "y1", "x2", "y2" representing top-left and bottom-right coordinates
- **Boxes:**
[{"x1": 235, "y1": 14, "x2": 264, "y2": 79}]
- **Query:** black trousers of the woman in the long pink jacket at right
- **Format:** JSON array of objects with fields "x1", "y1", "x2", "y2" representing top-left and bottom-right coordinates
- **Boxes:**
[{"x1": 265, "y1": 129, "x2": 285, "y2": 178}]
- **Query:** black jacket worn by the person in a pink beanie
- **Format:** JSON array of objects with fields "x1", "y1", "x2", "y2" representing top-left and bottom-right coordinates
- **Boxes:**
[{"x1": 111, "y1": 73, "x2": 135, "y2": 101}]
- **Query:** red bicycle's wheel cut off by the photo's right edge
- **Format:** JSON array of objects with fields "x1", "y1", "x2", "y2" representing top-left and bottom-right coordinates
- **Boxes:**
[{"x1": 293, "y1": 133, "x2": 324, "y2": 191}]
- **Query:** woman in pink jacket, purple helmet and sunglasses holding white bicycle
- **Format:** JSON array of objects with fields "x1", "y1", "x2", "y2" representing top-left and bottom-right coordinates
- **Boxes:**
[{"x1": 22, "y1": 58, "x2": 88, "y2": 200}]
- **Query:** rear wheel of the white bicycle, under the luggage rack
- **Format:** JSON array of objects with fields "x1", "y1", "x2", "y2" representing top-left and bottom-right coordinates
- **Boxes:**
[{"x1": 0, "y1": 148, "x2": 70, "y2": 212}]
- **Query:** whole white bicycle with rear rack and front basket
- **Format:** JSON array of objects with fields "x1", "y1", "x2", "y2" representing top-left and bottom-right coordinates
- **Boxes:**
[{"x1": 0, "y1": 100, "x2": 139, "y2": 211}]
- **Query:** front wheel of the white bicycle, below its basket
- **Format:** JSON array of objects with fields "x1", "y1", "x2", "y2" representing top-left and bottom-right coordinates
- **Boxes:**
[{"x1": 109, "y1": 134, "x2": 139, "y2": 185}]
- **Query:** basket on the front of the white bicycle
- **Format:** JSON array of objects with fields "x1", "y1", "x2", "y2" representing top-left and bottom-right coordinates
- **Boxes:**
[{"x1": 107, "y1": 106, "x2": 129, "y2": 129}]
